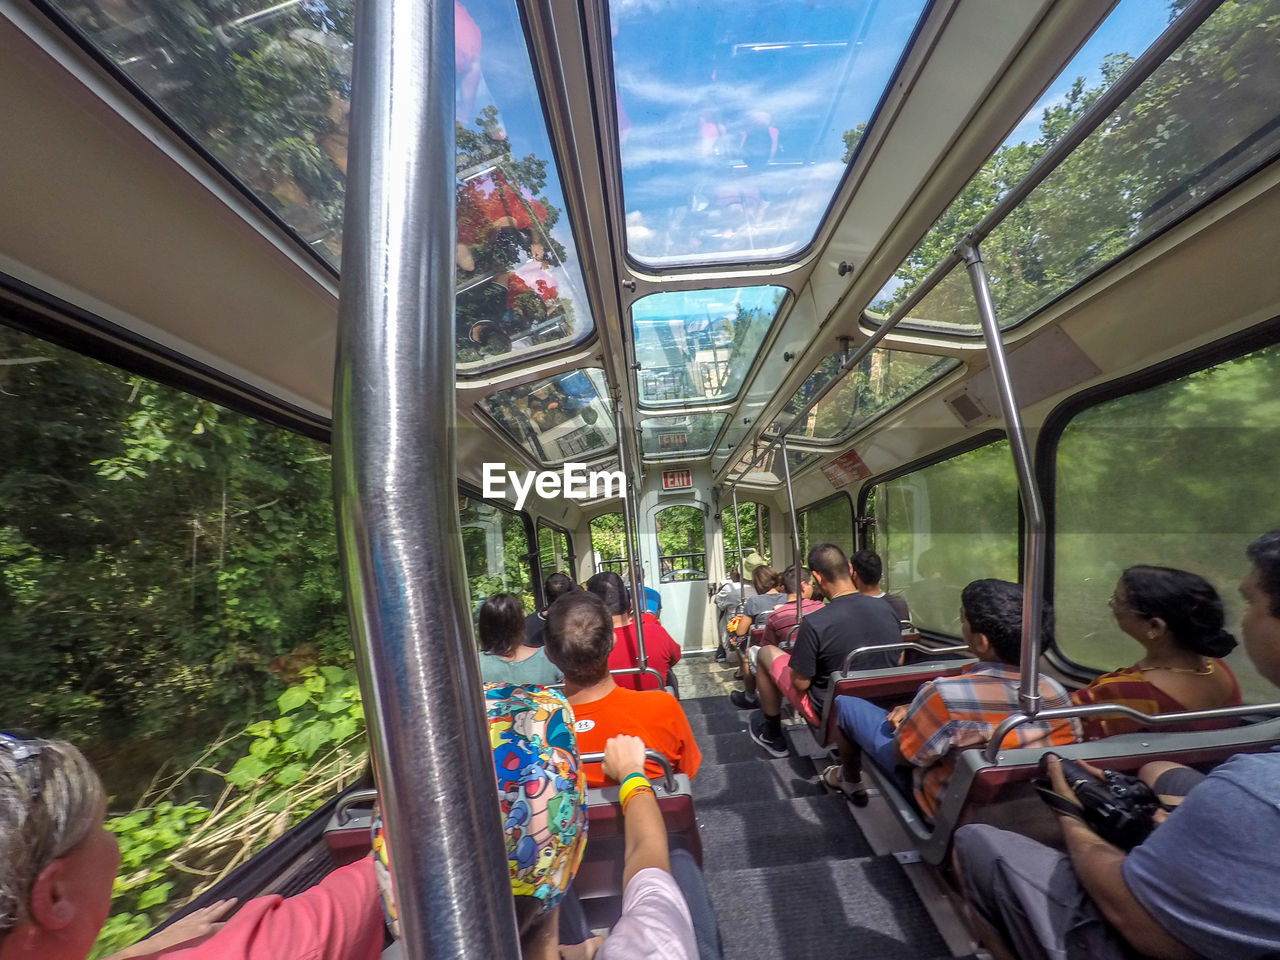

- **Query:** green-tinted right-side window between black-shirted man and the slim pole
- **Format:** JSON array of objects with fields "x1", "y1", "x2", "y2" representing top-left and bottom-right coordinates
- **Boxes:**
[{"x1": 869, "y1": 440, "x2": 1019, "y2": 636}]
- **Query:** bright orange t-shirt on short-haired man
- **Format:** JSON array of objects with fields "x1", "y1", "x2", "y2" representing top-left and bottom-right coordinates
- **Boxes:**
[{"x1": 573, "y1": 686, "x2": 703, "y2": 787}]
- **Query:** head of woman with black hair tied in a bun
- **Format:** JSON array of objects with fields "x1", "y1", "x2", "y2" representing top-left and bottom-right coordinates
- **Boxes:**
[{"x1": 1111, "y1": 566, "x2": 1235, "y2": 657}]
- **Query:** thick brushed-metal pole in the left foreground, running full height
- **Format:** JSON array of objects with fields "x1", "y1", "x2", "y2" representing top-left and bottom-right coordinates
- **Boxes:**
[{"x1": 333, "y1": 0, "x2": 520, "y2": 960}]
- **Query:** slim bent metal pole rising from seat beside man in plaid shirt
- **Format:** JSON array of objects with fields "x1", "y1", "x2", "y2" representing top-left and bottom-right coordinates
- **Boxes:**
[{"x1": 957, "y1": 243, "x2": 1044, "y2": 717}]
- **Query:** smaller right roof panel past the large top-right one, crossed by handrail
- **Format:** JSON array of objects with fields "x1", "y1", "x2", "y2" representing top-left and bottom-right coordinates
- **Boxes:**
[{"x1": 774, "y1": 348, "x2": 960, "y2": 443}]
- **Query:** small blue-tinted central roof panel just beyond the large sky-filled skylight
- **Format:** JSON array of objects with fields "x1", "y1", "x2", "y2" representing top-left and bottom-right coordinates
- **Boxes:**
[{"x1": 631, "y1": 287, "x2": 787, "y2": 406}]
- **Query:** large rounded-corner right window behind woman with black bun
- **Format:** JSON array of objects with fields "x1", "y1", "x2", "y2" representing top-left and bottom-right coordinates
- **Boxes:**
[{"x1": 1053, "y1": 346, "x2": 1280, "y2": 703}]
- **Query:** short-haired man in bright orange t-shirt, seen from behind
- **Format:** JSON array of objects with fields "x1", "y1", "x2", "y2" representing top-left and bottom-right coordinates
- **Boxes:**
[{"x1": 547, "y1": 593, "x2": 701, "y2": 787}]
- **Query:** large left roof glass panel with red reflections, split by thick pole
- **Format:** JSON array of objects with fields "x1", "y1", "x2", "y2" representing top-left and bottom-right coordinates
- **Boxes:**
[{"x1": 51, "y1": 0, "x2": 593, "y2": 371}]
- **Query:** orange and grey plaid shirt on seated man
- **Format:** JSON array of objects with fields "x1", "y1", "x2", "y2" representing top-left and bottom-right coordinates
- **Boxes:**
[{"x1": 896, "y1": 662, "x2": 1080, "y2": 817}]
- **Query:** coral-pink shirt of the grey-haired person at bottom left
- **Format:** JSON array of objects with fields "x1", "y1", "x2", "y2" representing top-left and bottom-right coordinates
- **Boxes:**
[{"x1": 152, "y1": 856, "x2": 384, "y2": 960}]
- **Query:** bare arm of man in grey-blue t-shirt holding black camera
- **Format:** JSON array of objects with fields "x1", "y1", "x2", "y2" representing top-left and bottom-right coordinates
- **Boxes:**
[{"x1": 1048, "y1": 758, "x2": 1196, "y2": 960}]
